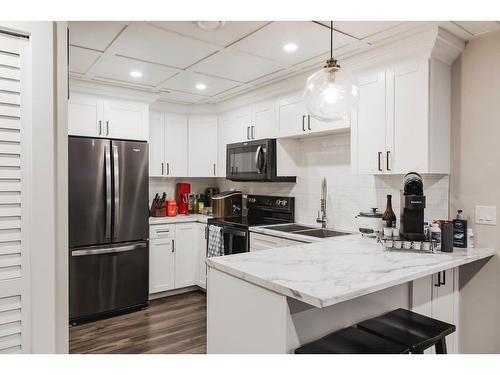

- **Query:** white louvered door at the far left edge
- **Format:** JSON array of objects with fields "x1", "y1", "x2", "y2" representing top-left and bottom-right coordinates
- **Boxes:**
[{"x1": 0, "y1": 32, "x2": 29, "y2": 353}]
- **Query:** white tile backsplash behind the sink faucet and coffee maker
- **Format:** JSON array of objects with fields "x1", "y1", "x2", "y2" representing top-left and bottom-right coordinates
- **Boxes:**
[{"x1": 219, "y1": 133, "x2": 449, "y2": 231}]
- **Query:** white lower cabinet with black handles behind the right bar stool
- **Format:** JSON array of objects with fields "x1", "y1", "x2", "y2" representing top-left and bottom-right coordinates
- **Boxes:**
[{"x1": 411, "y1": 267, "x2": 459, "y2": 354}]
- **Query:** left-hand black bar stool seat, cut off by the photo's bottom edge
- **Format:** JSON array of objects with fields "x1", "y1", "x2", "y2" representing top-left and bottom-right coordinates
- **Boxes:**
[{"x1": 295, "y1": 327, "x2": 409, "y2": 354}]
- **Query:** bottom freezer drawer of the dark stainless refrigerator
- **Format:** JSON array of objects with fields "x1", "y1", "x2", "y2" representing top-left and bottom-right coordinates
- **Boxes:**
[{"x1": 69, "y1": 241, "x2": 149, "y2": 321}]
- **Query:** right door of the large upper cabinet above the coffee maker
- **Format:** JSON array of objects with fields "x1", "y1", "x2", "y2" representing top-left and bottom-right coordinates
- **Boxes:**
[{"x1": 386, "y1": 60, "x2": 429, "y2": 174}]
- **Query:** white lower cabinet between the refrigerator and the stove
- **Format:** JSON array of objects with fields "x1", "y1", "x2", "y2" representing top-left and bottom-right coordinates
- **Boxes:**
[{"x1": 149, "y1": 222, "x2": 206, "y2": 294}]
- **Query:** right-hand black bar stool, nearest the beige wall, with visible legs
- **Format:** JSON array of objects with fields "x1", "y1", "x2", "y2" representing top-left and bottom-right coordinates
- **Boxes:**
[{"x1": 357, "y1": 309, "x2": 456, "y2": 354}]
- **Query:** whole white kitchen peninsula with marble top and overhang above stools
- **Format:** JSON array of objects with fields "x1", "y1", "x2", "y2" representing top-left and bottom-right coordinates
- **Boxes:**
[{"x1": 207, "y1": 235, "x2": 495, "y2": 353}]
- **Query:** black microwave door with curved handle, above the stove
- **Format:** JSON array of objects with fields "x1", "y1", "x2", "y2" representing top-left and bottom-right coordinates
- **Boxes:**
[{"x1": 226, "y1": 140, "x2": 272, "y2": 181}]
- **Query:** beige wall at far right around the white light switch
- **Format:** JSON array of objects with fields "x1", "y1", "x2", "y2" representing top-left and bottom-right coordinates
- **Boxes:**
[{"x1": 450, "y1": 32, "x2": 500, "y2": 353}]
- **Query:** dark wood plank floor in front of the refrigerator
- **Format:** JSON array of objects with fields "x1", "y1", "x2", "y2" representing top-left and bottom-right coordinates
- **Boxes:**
[{"x1": 69, "y1": 291, "x2": 207, "y2": 354}]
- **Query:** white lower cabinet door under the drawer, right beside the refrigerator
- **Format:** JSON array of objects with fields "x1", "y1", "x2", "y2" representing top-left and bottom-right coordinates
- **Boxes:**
[{"x1": 149, "y1": 238, "x2": 175, "y2": 294}]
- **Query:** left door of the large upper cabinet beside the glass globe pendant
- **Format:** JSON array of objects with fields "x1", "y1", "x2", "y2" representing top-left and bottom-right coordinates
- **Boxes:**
[{"x1": 351, "y1": 71, "x2": 386, "y2": 174}]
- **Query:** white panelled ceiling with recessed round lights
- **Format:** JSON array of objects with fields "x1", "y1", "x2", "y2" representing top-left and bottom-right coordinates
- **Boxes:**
[{"x1": 69, "y1": 21, "x2": 500, "y2": 104}]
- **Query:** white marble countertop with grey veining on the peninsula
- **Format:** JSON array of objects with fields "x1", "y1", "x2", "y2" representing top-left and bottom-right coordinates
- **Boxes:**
[{"x1": 207, "y1": 234, "x2": 496, "y2": 307}]
